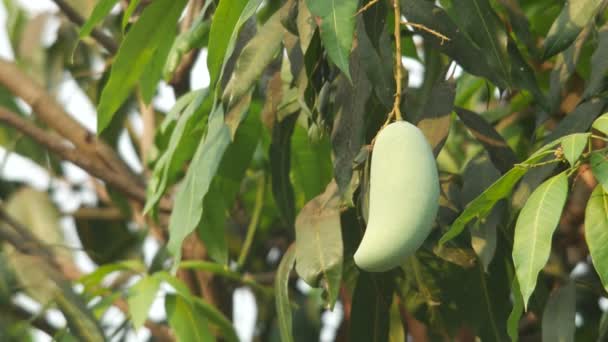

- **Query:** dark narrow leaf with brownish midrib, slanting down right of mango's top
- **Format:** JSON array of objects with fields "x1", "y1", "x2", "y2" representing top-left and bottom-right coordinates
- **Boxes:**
[{"x1": 456, "y1": 107, "x2": 517, "y2": 174}]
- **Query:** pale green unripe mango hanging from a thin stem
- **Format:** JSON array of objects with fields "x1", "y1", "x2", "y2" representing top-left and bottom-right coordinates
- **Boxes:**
[{"x1": 354, "y1": 121, "x2": 439, "y2": 272}]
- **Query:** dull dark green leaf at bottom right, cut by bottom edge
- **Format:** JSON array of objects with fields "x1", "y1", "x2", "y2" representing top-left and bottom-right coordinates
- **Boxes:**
[{"x1": 542, "y1": 281, "x2": 576, "y2": 342}]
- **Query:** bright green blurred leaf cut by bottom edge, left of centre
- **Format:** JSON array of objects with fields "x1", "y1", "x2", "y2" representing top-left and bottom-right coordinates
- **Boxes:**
[{"x1": 165, "y1": 294, "x2": 215, "y2": 341}]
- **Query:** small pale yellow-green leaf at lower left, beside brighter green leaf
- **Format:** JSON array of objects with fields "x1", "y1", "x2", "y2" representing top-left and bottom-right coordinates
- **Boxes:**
[{"x1": 127, "y1": 276, "x2": 160, "y2": 330}]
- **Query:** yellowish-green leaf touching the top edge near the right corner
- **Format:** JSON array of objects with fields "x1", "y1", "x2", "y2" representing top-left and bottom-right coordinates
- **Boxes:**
[{"x1": 543, "y1": 0, "x2": 602, "y2": 59}]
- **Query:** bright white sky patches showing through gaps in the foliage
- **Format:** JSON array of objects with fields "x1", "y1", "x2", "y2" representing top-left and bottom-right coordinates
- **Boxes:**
[{"x1": 0, "y1": 0, "x2": 422, "y2": 341}]
